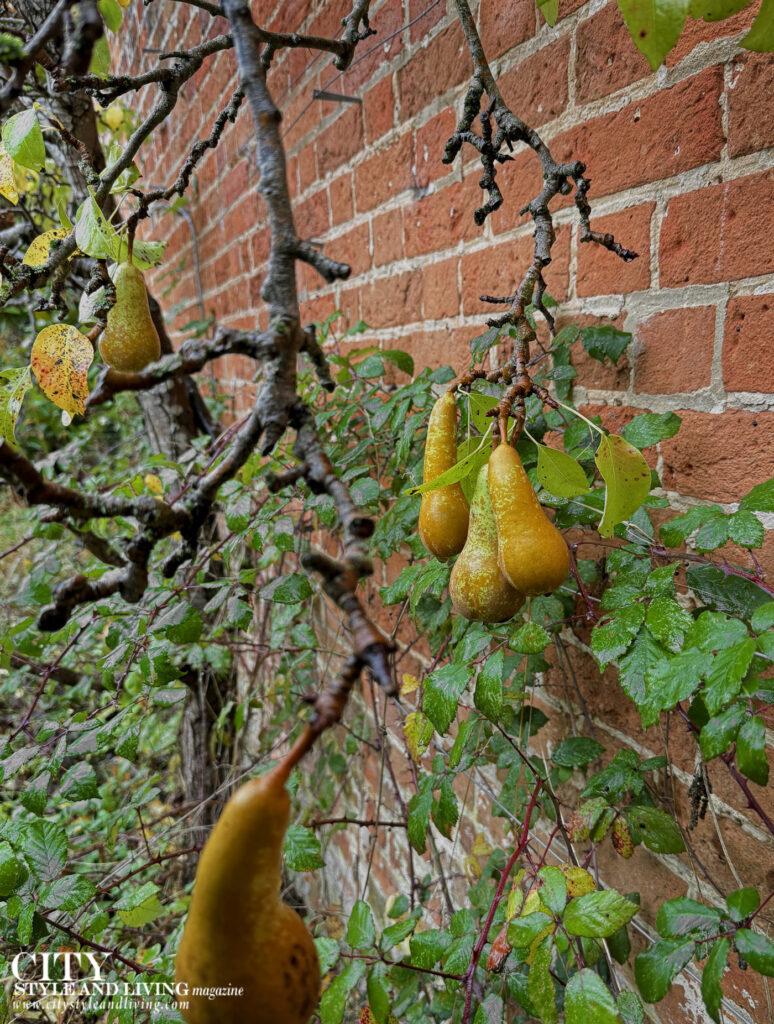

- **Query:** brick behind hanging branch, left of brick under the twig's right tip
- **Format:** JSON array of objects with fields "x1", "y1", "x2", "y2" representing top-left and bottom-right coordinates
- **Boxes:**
[{"x1": 462, "y1": 227, "x2": 569, "y2": 314}]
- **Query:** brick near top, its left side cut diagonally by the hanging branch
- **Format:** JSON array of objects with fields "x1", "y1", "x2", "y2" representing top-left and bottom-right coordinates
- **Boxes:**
[{"x1": 498, "y1": 36, "x2": 569, "y2": 128}]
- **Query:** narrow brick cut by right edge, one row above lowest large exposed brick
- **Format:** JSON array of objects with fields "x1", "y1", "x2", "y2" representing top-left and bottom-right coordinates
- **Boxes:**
[{"x1": 723, "y1": 295, "x2": 774, "y2": 394}]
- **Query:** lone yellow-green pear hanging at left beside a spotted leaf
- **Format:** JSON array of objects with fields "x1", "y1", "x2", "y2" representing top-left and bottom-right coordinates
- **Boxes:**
[{"x1": 99, "y1": 263, "x2": 161, "y2": 374}]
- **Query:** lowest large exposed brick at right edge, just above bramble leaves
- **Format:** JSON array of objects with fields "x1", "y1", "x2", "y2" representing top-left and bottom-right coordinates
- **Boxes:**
[{"x1": 661, "y1": 410, "x2": 774, "y2": 502}]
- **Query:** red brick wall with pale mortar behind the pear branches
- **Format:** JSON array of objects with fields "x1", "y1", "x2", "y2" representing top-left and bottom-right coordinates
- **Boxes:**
[{"x1": 116, "y1": 0, "x2": 774, "y2": 1024}]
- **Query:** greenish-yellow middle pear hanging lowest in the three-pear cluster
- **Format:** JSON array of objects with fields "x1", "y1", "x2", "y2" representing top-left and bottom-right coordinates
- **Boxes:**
[{"x1": 448, "y1": 465, "x2": 524, "y2": 623}]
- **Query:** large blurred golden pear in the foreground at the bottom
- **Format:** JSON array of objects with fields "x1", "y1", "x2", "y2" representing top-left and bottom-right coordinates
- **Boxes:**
[{"x1": 175, "y1": 765, "x2": 319, "y2": 1024}]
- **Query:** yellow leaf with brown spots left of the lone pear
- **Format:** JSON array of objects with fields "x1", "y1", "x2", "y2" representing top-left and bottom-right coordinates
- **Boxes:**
[{"x1": 30, "y1": 324, "x2": 94, "y2": 416}]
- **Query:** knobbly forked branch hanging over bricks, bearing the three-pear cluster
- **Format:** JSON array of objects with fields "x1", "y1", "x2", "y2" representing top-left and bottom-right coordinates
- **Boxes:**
[{"x1": 442, "y1": 0, "x2": 637, "y2": 443}]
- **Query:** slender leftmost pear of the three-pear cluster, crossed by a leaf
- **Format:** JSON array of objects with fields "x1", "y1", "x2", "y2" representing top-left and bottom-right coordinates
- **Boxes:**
[{"x1": 419, "y1": 391, "x2": 470, "y2": 561}]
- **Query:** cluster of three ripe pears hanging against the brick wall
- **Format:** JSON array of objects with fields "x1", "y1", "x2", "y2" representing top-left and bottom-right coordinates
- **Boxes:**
[{"x1": 419, "y1": 391, "x2": 569, "y2": 623}]
